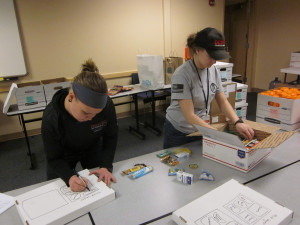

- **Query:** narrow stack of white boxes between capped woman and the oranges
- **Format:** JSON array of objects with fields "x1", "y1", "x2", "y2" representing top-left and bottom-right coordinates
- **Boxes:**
[{"x1": 235, "y1": 83, "x2": 248, "y2": 119}]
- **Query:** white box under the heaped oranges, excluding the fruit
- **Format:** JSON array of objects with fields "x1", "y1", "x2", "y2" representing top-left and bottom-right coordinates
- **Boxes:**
[{"x1": 256, "y1": 94, "x2": 300, "y2": 131}]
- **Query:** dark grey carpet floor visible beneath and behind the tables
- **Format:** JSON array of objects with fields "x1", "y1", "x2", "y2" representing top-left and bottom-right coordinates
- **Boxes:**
[{"x1": 0, "y1": 93, "x2": 257, "y2": 192}]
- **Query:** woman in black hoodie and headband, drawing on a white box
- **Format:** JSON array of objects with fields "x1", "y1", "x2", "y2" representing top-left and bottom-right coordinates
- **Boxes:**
[{"x1": 42, "y1": 60, "x2": 118, "y2": 191}]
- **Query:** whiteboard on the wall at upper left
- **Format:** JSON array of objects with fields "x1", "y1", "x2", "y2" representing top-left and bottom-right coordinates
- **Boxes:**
[{"x1": 0, "y1": 0, "x2": 27, "y2": 78}]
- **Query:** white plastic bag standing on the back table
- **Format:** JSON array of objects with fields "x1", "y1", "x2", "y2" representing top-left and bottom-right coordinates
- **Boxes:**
[{"x1": 136, "y1": 55, "x2": 164, "y2": 90}]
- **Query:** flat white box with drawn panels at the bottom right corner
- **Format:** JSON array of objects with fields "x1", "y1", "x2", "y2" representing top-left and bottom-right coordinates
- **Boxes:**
[{"x1": 172, "y1": 180, "x2": 293, "y2": 225}]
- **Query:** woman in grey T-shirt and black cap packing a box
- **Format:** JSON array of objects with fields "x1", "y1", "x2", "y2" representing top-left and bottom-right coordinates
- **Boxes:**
[{"x1": 164, "y1": 27, "x2": 254, "y2": 148}]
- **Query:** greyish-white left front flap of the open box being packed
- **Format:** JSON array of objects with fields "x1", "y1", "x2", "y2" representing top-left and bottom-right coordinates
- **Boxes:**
[{"x1": 194, "y1": 124, "x2": 245, "y2": 149}]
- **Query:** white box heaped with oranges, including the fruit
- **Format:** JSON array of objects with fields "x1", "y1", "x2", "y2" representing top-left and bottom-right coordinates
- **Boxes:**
[{"x1": 256, "y1": 87, "x2": 300, "y2": 131}]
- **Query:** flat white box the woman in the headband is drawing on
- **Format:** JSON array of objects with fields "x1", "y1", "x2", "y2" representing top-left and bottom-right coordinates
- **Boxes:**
[{"x1": 15, "y1": 170, "x2": 115, "y2": 225}]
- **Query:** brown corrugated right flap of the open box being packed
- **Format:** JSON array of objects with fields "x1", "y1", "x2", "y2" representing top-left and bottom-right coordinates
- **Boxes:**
[{"x1": 252, "y1": 131, "x2": 296, "y2": 149}]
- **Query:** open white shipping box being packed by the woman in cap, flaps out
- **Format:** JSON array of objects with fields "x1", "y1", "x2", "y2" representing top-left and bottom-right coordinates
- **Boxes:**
[{"x1": 194, "y1": 120, "x2": 295, "y2": 173}]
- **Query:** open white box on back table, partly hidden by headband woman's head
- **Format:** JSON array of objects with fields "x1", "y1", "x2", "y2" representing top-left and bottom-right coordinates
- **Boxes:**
[{"x1": 41, "y1": 77, "x2": 71, "y2": 105}]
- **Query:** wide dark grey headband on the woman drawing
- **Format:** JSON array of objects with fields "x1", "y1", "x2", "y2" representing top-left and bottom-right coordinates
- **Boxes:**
[{"x1": 72, "y1": 81, "x2": 108, "y2": 109}]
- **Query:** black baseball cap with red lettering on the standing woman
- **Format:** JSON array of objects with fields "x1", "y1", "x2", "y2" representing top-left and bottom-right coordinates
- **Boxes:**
[{"x1": 195, "y1": 27, "x2": 231, "y2": 60}]
